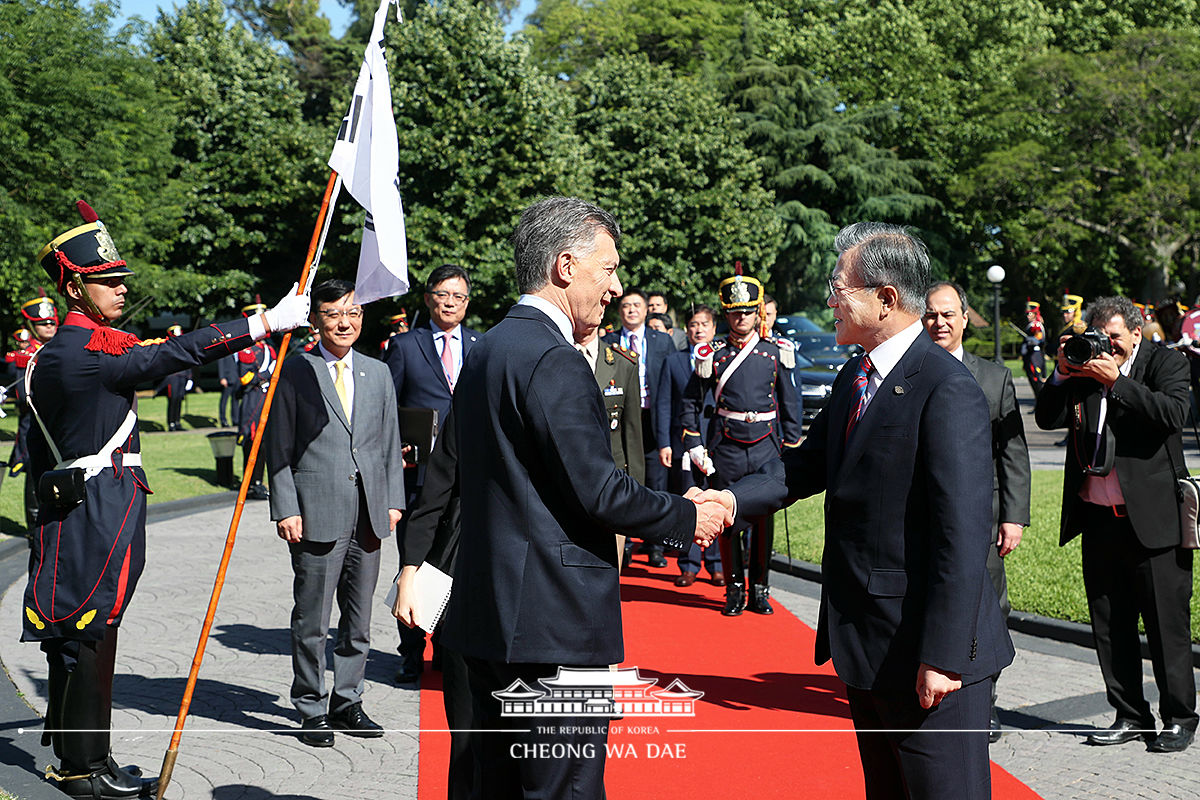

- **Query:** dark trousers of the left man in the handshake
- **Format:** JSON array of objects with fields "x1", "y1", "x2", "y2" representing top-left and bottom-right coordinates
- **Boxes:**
[{"x1": 466, "y1": 657, "x2": 608, "y2": 800}]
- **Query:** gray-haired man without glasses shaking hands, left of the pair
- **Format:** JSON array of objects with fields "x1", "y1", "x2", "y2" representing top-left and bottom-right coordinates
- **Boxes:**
[{"x1": 443, "y1": 197, "x2": 727, "y2": 800}]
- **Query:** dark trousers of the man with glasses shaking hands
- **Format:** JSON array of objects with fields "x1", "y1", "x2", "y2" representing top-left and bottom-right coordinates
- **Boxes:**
[{"x1": 846, "y1": 670, "x2": 991, "y2": 800}]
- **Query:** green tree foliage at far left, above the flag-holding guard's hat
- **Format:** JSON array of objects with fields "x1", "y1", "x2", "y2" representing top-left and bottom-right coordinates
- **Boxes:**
[{"x1": 0, "y1": 0, "x2": 172, "y2": 308}]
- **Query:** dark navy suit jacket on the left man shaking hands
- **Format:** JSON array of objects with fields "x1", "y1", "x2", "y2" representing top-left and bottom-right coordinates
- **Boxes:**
[{"x1": 443, "y1": 305, "x2": 696, "y2": 666}]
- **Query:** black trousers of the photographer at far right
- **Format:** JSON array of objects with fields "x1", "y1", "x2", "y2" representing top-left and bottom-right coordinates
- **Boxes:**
[{"x1": 1082, "y1": 498, "x2": 1196, "y2": 730}]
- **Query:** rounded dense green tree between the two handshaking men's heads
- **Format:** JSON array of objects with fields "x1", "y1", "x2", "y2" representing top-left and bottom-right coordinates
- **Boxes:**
[{"x1": 572, "y1": 56, "x2": 780, "y2": 309}]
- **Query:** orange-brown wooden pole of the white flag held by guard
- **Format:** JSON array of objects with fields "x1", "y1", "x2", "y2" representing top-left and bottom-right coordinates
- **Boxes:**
[{"x1": 157, "y1": 172, "x2": 338, "y2": 800}]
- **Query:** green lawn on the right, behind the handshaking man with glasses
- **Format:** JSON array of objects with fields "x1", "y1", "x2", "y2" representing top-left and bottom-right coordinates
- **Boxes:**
[{"x1": 775, "y1": 470, "x2": 1200, "y2": 642}]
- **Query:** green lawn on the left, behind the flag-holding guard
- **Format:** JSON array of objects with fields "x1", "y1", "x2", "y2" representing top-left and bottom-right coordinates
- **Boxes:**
[{"x1": 0, "y1": 392, "x2": 241, "y2": 534}]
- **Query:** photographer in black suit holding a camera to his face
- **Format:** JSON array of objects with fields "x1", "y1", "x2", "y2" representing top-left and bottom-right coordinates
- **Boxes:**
[{"x1": 1036, "y1": 297, "x2": 1198, "y2": 752}]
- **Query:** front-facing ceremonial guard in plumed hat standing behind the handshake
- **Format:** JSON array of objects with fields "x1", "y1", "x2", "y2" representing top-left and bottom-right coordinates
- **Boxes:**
[{"x1": 680, "y1": 275, "x2": 800, "y2": 616}]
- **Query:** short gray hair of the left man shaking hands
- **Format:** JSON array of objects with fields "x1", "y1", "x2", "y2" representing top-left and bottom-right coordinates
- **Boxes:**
[{"x1": 512, "y1": 197, "x2": 620, "y2": 294}]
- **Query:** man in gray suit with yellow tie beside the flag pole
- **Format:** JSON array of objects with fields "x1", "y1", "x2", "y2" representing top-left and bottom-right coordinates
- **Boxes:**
[{"x1": 266, "y1": 279, "x2": 404, "y2": 747}]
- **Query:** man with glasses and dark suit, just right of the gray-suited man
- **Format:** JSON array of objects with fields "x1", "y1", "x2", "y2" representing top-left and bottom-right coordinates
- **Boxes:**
[{"x1": 383, "y1": 264, "x2": 481, "y2": 684}]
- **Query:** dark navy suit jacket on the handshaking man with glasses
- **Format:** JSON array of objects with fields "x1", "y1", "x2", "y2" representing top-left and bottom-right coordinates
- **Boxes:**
[{"x1": 732, "y1": 335, "x2": 1014, "y2": 692}]
